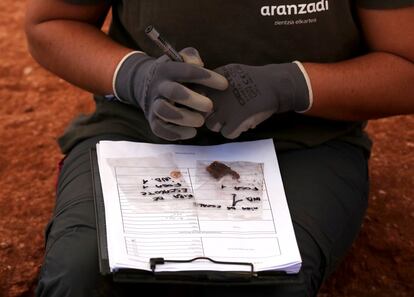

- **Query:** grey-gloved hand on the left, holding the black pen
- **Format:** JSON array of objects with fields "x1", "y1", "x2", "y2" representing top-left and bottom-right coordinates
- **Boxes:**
[{"x1": 114, "y1": 48, "x2": 228, "y2": 141}]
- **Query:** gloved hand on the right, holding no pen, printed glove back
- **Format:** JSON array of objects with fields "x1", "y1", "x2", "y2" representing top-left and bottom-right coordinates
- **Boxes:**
[{"x1": 206, "y1": 62, "x2": 312, "y2": 139}]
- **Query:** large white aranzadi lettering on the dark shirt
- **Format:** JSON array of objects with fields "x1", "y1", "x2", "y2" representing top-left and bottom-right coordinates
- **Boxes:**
[{"x1": 260, "y1": 0, "x2": 329, "y2": 16}]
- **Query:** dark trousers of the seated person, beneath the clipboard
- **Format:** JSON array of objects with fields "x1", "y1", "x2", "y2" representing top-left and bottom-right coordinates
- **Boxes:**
[{"x1": 36, "y1": 135, "x2": 368, "y2": 297}]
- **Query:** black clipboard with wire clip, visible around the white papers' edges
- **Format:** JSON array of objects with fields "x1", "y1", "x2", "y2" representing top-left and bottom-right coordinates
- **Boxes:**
[{"x1": 90, "y1": 148, "x2": 303, "y2": 286}]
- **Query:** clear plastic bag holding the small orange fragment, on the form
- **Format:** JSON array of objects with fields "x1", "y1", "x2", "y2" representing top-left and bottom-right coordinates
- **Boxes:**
[{"x1": 108, "y1": 153, "x2": 194, "y2": 211}]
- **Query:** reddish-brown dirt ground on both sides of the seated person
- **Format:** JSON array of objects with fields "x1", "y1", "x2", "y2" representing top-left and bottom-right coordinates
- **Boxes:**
[{"x1": 0, "y1": 0, "x2": 414, "y2": 297}]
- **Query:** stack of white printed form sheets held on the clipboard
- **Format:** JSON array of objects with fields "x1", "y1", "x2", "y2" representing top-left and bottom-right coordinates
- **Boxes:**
[{"x1": 97, "y1": 140, "x2": 301, "y2": 273}]
